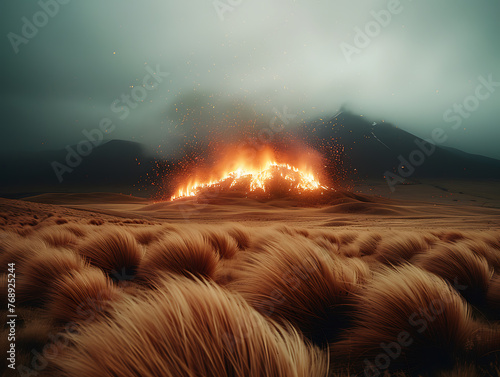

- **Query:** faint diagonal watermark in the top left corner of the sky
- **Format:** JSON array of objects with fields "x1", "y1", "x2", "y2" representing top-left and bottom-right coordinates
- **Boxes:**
[{"x1": 7, "y1": 0, "x2": 71, "y2": 54}]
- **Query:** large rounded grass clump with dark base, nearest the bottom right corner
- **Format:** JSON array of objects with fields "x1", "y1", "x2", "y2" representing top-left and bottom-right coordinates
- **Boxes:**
[{"x1": 330, "y1": 265, "x2": 476, "y2": 375}]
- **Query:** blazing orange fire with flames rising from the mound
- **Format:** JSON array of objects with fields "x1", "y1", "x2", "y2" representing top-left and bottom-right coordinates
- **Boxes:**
[{"x1": 170, "y1": 147, "x2": 329, "y2": 200}]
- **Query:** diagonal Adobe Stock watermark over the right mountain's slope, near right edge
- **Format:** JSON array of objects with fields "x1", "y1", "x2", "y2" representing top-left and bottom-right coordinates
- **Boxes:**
[{"x1": 384, "y1": 74, "x2": 500, "y2": 192}]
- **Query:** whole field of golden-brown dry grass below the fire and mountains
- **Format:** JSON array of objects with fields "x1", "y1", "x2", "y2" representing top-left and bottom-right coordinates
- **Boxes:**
[{"x1": 0, "y1": 186, "x2": 500, "y2": 377}]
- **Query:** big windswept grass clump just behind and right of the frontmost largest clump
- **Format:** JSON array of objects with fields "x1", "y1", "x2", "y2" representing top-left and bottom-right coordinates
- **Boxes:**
[{"x1": 231, "y1": 236, "x2": 368, "y2": 344}]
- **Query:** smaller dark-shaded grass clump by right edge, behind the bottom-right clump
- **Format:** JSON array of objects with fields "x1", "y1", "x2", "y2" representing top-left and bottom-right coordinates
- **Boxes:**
[{"x1": 414, "y1": 244, "x2": 493, "y2": 305}]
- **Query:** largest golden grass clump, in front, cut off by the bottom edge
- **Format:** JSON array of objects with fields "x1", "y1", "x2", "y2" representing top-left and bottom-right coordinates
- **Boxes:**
[{"x1": 54, "y1": 277, "x2": 328, "y2": 377}]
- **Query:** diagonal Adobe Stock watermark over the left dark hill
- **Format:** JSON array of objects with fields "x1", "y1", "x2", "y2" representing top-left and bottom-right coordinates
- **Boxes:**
[{"x1": 51, "y1": 64, "x2": 170, "y2": 183}]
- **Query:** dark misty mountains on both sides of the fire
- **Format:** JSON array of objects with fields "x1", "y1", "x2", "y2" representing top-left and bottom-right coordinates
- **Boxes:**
[{"x1": 0, "y1": 111, "x2": 500, "y2": 197}]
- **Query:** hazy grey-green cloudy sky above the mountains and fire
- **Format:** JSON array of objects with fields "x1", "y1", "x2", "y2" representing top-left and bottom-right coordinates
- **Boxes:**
[{"x1": 0, "y1": 0, "x2": 500, "y2": 159}]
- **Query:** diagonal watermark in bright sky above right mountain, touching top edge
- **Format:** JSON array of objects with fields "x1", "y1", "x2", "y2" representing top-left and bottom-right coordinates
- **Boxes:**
[{"x1": 340, "y1": 0, "x2": 413, "y2": 63}]
